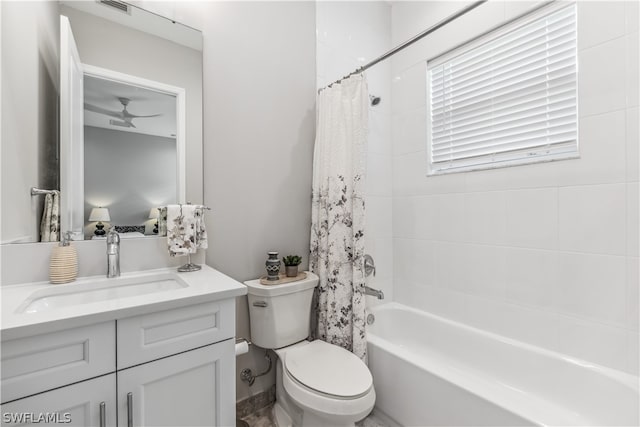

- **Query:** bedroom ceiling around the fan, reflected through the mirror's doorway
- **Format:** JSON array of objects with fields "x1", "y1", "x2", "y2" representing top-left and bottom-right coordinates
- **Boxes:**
[{"x1": 84, "y1": 75, "x2": 177, "y2": 138}]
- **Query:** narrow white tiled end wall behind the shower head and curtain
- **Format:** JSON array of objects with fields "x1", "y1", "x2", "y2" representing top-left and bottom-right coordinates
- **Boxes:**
[{"x1": 316, "y1": 1, "x2": 393, "y2": 304}]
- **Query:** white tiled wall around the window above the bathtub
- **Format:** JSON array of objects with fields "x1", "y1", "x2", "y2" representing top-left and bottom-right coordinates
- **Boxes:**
[{"x1": 390, "y1": 1, "x2": 640, "y2": 374}]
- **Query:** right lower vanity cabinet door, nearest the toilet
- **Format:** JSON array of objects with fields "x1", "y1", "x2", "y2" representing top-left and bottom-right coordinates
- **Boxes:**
[{"x1": 117, "y1": 339, "x2": 236, "y2": 427}]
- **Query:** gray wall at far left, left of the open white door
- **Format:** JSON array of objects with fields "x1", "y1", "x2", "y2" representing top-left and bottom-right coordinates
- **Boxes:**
[{"x1": 0, "y1": 1, "x2": 60, "y2": 243}]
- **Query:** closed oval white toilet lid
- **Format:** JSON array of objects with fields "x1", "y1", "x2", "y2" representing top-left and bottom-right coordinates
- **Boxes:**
[{"x1": 285, "y1": 340, "x2": 373, "y2": 397}]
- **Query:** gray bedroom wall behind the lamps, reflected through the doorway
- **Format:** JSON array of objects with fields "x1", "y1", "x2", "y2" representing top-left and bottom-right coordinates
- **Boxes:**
[{"x1": 84, "y1": 126, "x2": 177, "y2": 238}]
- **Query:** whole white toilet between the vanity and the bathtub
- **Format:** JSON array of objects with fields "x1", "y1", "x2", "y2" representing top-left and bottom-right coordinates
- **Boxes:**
[{"x1": 245, "y1": 272, "x2": 376, "y2": 427}]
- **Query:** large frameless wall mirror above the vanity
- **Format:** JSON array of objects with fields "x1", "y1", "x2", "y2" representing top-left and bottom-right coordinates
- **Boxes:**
[{"x1": 0, "y1": 0, "x2": 203, "y2": 243}]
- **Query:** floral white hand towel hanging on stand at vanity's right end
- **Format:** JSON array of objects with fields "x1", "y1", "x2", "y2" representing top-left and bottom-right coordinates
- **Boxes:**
[{"x1": 167, "y1": 205, "x2": 208, "y2": 256}]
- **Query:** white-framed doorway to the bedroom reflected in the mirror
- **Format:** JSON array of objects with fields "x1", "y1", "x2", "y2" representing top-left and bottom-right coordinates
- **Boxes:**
[{"x1": 81, "y1": 66, "x2": 185, "y2": 239}]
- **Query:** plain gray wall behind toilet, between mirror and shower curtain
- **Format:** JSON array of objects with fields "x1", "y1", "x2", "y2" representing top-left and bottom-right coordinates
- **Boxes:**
[{"x1": 203, "y1": 2, "x2": 316, "y2": 399}]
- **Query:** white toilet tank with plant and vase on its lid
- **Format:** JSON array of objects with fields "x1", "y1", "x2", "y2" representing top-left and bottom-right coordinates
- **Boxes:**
[{"x1": 244, "y1": 272, "x2": 318, "y2": 348}]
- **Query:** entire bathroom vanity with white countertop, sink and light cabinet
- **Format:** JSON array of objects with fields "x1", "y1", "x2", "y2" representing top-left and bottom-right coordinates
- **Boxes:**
[{"x1": 1, "y1": 266, "x2": 246, "y2": 426}]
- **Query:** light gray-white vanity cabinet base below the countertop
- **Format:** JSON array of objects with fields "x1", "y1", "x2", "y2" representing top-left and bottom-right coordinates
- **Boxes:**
[{"x1": 1, "y1": 298, "x2": 235, "y2": 427}]
